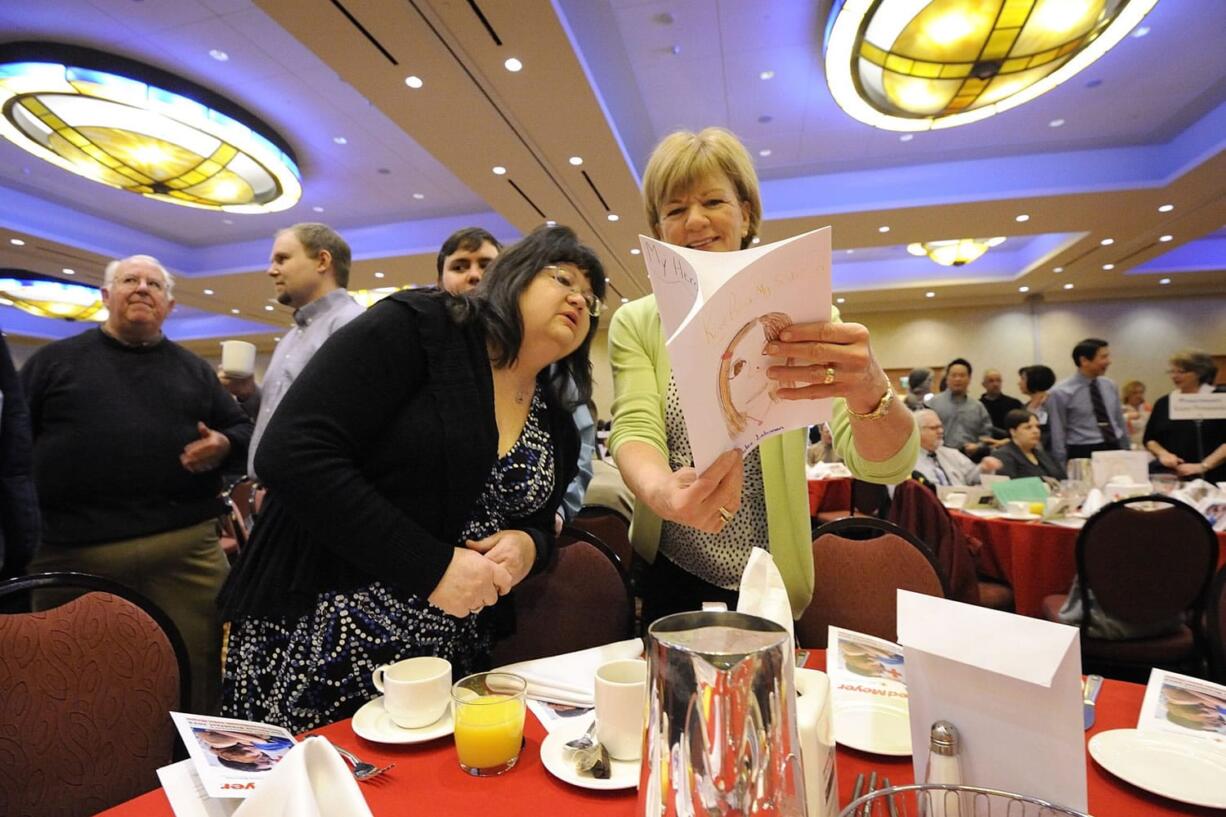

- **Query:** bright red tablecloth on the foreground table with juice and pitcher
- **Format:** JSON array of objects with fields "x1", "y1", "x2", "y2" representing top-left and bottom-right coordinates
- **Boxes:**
[{"x1": 102, "y1": 650, "x2": 1221, "y2": 817}]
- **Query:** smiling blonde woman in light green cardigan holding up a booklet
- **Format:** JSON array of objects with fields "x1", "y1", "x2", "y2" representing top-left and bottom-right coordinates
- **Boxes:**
[{"x1": 609, "y1": 128, "x2": 918, "y2": 624}]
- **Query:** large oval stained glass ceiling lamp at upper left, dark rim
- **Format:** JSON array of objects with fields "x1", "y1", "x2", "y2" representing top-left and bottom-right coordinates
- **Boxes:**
[{"x1": 0, "y1": 43, "x2": 302, "y2": 213}]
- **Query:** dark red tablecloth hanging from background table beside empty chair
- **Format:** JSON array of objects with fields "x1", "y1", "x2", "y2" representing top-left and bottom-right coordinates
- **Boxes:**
[{"x1": 950, "y1": 510, "x2": 1226, "y2": 616}]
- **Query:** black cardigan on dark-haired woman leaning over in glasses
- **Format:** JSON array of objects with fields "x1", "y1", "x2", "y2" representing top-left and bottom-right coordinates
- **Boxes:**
[{"x1": 219, "y1": 291, "x2": 579, "y2": 620}]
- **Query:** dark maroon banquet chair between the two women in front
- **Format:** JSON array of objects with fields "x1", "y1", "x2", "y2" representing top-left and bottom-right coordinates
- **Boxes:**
[{"x1": 493, "y1": 526, "x2": 635, "y2": 666}]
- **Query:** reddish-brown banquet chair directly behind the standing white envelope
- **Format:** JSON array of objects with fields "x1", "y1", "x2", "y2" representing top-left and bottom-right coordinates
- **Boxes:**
[{"x1": 796, "y1": 516, "x2": 948, "y2": 649}]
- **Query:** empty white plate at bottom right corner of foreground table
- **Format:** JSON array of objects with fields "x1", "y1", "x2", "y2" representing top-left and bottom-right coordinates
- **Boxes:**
[{"x1": 1090, "y1": 729, "x2": 1226, "y2": 808}]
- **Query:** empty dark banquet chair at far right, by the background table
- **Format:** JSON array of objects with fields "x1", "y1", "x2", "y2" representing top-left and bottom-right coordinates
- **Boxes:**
[{"x1": 1042, "y1": 494, "x2": 1217, "y2": 678}]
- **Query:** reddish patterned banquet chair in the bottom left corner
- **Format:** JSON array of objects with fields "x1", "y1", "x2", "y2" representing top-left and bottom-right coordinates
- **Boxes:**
[{"x1": 0, "y1": 573, "x2": 191, "y2": 817}]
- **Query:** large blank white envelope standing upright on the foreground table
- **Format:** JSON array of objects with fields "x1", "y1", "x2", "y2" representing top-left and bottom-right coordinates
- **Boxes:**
[{"x1": 897, "y1": 590, "x2": 1086, "y2": 811}]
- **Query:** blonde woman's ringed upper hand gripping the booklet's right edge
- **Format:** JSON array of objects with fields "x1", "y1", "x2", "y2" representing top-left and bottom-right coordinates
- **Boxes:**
[{"x1": 766, "y1": 321, "x2": 889, "y2": 413}]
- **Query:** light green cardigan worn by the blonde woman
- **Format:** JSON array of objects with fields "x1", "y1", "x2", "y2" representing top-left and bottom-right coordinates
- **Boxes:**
[{"x1": 609, "y1": 296, "x2": 920, "y2": 617}]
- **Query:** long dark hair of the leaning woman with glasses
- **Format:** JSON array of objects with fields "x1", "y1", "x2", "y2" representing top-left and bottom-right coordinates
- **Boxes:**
[{"x1": 451, "y1": 227, "x2": 604, "y2": 411}]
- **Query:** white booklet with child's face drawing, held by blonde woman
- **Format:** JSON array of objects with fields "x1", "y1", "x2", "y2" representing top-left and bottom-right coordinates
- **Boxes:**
[{"x1": 639, "y1": 227, "x2": 830, "y2": 472}]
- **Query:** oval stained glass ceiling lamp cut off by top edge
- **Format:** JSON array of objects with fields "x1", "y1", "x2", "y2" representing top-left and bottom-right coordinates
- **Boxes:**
[{"x1": 825, "y1": 0, "x2": 1157, "y2": 131}]
